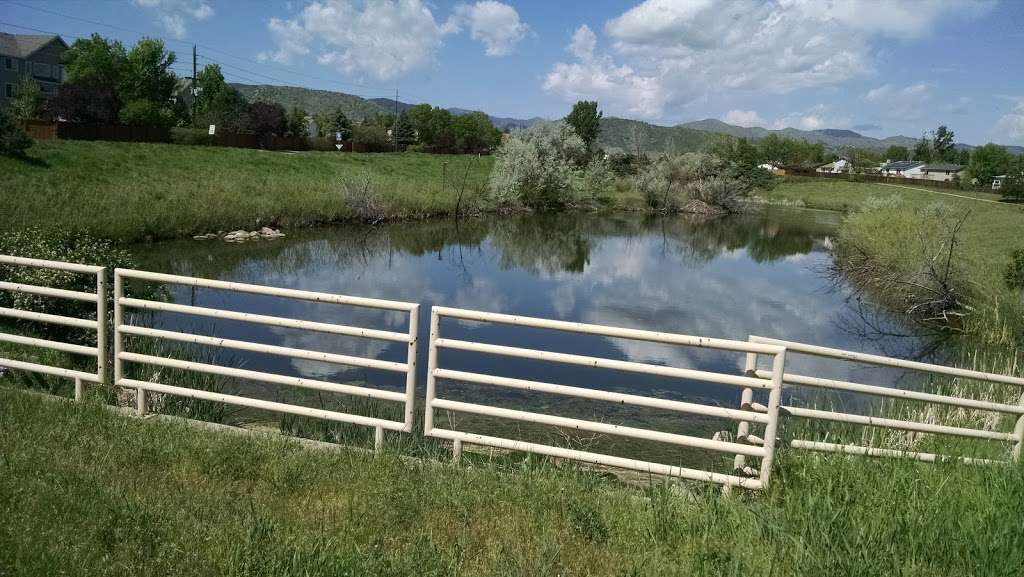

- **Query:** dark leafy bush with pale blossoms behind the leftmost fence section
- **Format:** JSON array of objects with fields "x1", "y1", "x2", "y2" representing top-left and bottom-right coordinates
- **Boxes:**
[{"x1": 0, "y1": 229, "x2": 135, "y2": 340}]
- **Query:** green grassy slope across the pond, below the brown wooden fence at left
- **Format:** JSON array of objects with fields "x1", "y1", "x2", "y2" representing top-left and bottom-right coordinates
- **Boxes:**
[{"x1": 0, "y1": 140, "x2": 493, "y2": 241}]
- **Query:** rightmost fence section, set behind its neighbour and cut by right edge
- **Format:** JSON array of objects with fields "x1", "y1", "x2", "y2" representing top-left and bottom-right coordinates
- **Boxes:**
[{"x1": 737, "y1": 336, "x2": 1024, "y2": 463}]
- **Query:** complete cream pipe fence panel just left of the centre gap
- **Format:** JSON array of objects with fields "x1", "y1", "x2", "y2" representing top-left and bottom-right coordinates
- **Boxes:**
[{"x1": 114, "y1": 269, "x2": 420, "y2": 448}]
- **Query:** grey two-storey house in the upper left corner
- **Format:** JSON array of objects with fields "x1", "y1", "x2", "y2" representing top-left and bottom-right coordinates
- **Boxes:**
[{"x1": 0, "y1": 32, "x2": 68, "y2": 108}]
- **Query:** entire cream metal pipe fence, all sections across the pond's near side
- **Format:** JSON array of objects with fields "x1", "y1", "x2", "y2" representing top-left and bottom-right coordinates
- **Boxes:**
[{"x1": 6, "y1": 255, "x2": 1024, "y2": 489}]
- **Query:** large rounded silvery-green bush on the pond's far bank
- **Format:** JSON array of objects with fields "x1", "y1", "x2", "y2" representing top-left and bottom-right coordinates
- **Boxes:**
[{"x1": 489, "y1": 122, "x2": 607, "y2": 210}]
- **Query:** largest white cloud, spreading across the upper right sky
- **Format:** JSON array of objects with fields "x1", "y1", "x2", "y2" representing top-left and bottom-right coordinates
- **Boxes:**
[{"x1": 545, "y1": 0, "x2": 991, "y2": 120}]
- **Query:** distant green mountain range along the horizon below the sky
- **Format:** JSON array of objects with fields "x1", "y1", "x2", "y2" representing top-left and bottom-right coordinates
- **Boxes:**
[{"x1": 231, "y1": 84, "x2": 1024, "y2": 154}]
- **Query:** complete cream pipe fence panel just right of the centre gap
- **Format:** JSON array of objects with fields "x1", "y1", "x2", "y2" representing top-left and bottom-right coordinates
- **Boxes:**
[{"x1": 424, "y1": 306, "x2": 785, "y2": 489}]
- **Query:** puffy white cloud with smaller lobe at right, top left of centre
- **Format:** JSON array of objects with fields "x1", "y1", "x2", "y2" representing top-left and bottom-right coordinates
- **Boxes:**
[{"x1": 259, "y1": 0, "x2": 527, "y2": 80}]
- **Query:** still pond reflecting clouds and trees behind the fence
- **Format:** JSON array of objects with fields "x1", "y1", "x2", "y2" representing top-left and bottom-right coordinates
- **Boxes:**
[{"x1": 134, "y1": 209, "x2": 916, "y2": 463}]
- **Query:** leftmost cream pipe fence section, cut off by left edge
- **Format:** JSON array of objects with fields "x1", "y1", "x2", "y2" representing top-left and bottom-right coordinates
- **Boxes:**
[{"x1": 0, "y1": 254, "x2": 106, "y2": 400}]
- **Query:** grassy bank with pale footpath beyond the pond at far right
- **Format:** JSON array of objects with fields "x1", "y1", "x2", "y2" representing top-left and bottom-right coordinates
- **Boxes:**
[{"x1": 763, "y1": 178, "x2": 1024, "y2": 293}]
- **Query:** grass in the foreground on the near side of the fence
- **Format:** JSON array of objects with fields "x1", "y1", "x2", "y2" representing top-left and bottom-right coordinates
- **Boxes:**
[{"x1": 0, "y1": 388, "x2": 1024, "y2": 577}]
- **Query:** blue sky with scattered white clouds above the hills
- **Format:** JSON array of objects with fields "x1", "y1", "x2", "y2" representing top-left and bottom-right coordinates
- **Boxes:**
[{"x1": 0, "y1": 0, "x2": 1024, "y2": 145}]
